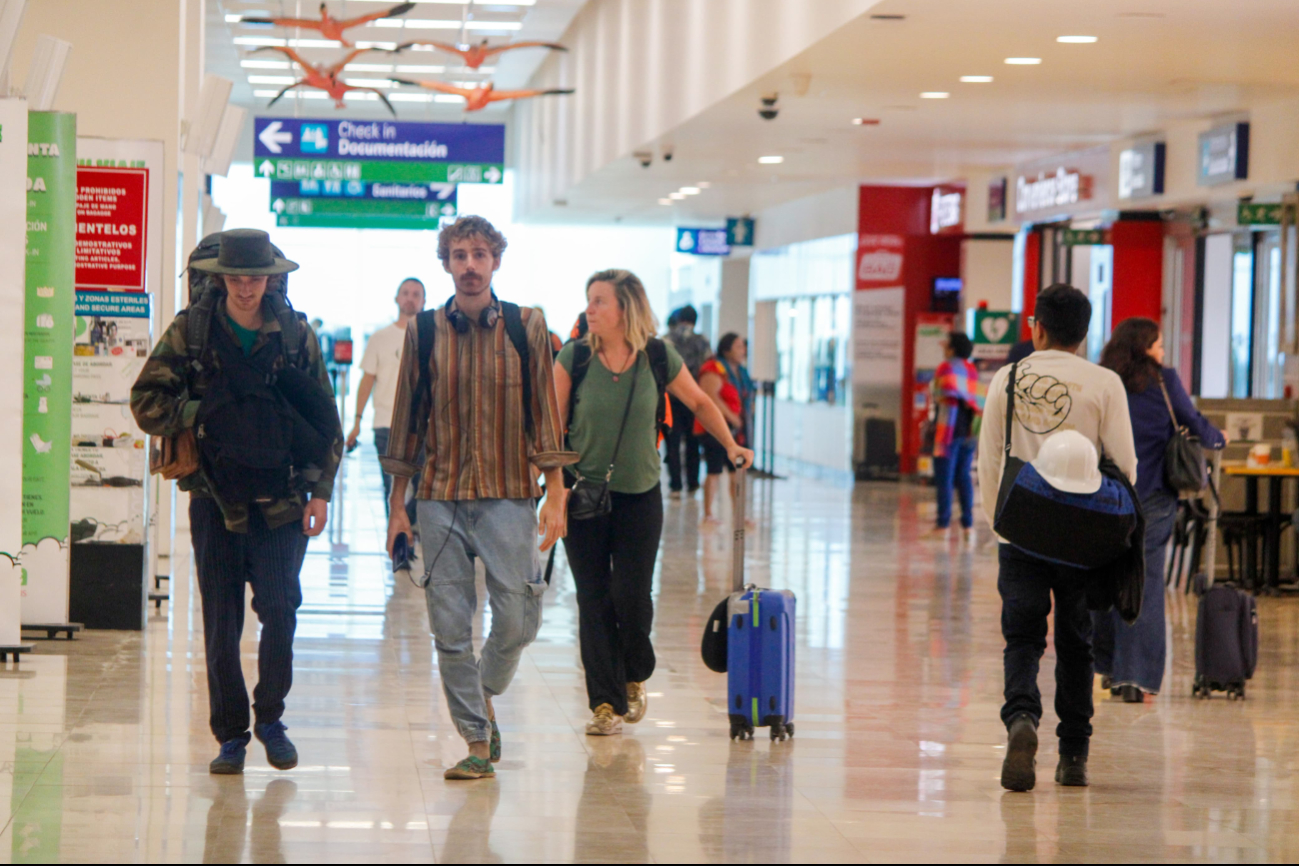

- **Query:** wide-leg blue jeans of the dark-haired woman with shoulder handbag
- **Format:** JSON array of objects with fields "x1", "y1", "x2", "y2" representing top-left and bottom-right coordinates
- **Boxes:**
[{"x1": 1091, "y1": 491, "x2": 1177, "y2": 695}]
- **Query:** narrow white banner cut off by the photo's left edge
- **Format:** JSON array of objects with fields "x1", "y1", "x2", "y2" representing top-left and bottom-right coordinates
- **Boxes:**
[{"x1": 0, "y1": 99, "x2": 27, "y2": 645}]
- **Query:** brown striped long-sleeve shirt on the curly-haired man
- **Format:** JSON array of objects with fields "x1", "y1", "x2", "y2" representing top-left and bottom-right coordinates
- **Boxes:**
[{"x1": 382, "y1": 303, "x2": 577, "y2": 500}]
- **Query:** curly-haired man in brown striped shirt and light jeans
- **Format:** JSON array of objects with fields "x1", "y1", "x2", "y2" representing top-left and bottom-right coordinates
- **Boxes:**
[{"x1": 382, "y1": 217, "x2": 577, "y2": 779}]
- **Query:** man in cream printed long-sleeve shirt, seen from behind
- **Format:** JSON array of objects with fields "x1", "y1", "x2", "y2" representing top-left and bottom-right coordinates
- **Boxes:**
[{"x1": 978, "y1": 283, "x2": 1137, "y2": 791}]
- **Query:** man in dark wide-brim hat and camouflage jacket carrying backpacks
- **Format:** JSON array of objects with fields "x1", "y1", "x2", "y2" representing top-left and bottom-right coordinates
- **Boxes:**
[{"x1": 131, "y1": 229, "x2": 343, "y2": 774}]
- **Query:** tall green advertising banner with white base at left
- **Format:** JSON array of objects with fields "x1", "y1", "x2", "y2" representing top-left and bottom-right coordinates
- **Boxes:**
[{"x1": 21, "y1": 112, "x2": 77, "y2": 623}]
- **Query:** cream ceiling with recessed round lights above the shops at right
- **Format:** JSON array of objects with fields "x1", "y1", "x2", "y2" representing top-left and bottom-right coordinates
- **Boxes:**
[{"x1": 542, "y1": 0, "x2": 1299, "y2": 222}]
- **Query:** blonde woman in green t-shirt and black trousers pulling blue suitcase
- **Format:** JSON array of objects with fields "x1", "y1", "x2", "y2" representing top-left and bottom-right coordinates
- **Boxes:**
[{"x1": 555, "y1": 270, "x2": 753, "y2": 736}]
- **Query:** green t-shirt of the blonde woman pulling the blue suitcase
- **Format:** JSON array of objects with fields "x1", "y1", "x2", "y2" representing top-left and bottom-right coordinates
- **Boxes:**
[{"x1": 559, "y1": 343, "x2": 682, "y2": 493}]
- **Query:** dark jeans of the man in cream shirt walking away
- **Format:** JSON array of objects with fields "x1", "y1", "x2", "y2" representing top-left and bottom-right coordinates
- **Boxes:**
[{"x1": 996, "y1": 544, "x2": 1092, "y2": 757}]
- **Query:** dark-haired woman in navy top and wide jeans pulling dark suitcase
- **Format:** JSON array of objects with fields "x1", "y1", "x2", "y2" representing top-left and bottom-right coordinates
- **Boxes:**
[{"x1": 1091, "y1": 318, "x2": 1226, "y2": 704}]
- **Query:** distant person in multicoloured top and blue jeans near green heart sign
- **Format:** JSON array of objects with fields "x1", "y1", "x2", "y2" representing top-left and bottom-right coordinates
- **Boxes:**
[{"x1": 934, "y1": 331, "x2": 983, "y2": 541}]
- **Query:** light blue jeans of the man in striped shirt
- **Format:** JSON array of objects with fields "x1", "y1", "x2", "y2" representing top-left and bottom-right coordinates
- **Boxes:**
[{"x1": 418, "y1": 499, "x2": 546, "y2": 743}]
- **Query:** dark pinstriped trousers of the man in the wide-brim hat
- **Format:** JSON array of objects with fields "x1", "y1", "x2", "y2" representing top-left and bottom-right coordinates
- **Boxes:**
[{"x1": 190, "y1": 497, "x2": 307, "y2": 743}]
